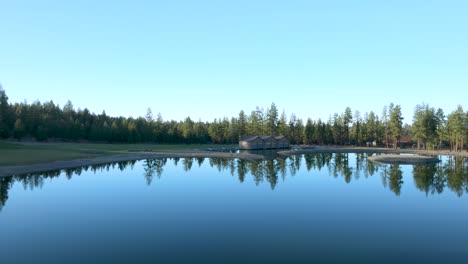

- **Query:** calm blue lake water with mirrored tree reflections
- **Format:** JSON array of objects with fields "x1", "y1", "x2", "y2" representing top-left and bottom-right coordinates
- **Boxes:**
[{"x1": 0, "y1": 154, "x2": 468, "y2": 263}]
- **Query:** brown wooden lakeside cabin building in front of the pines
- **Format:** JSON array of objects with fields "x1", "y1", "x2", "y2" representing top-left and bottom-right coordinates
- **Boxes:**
[{"x1": 239, "y1": 136, "x2": 289, "y2": 150}]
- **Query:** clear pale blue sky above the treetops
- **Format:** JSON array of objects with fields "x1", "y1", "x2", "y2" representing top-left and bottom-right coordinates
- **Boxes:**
[{"x1": 0, "y1": 0, "x2": 468, "y2": 123}]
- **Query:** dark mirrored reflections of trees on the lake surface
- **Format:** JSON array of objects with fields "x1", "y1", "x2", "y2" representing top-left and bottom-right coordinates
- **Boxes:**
[{"x1": 0, "y1": 156, "x2": 468, "y2": 210}]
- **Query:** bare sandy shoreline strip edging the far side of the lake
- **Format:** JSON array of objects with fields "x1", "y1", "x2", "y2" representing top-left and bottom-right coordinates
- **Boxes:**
[{"x1": 0, "y1": 146, "x2": 468, "y2": 177}]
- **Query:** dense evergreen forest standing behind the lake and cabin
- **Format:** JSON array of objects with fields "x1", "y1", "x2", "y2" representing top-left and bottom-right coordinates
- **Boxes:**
[{"x1": 0, "y1": 86, "x2": 468, "y2": 151}]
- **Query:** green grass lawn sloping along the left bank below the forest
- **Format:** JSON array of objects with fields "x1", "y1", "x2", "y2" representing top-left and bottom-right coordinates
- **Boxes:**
[{"x1": 0, "y1": 141, "x2": 233, "y2": 166}]
